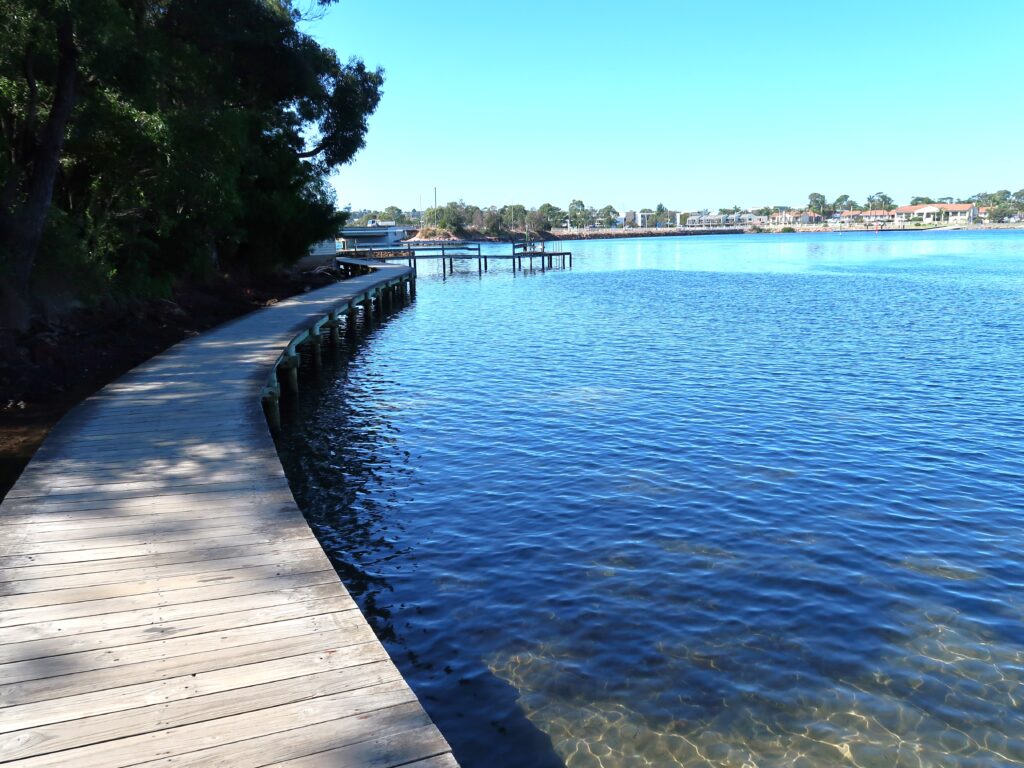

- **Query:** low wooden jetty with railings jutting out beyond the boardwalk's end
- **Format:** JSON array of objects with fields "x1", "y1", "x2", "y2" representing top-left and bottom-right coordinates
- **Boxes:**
[{"x1": 338, "y1": 240, "x2": 572, "y2": 275}]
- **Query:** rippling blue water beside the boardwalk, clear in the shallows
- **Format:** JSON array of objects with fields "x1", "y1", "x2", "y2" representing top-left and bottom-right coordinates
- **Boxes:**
[{"x1": 282, "y1": 232, "x2": 1024, "y2": 768}]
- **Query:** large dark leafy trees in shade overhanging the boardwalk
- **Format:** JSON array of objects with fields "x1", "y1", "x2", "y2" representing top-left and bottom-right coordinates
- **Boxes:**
[{"x1": 0, "y1": 0, "x2": 383, "y2": 327}]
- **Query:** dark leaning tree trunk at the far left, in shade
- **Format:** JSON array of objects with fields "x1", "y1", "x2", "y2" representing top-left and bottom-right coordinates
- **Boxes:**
[{"x1": 0, "y1": 13, "x2": 78, "y2": 326}]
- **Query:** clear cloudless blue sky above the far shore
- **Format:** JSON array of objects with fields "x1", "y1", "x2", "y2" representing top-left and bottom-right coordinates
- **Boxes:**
[{"x1": 308, "y1": 0, "x2": 1024, "y2": 211}]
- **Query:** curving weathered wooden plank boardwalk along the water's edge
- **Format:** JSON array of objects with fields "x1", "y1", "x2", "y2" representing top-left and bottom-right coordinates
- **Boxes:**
[{"x1": 0, "y1": 264, "x2": 456, "y2": 768}]
